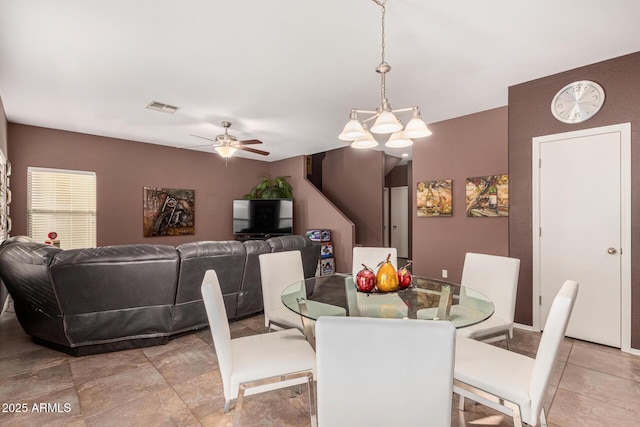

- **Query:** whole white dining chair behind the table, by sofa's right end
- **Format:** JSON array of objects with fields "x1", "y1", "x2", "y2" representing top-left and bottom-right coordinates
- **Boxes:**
[{"x1": 258, "y1": 251, "x2": 306, "y2": 331}]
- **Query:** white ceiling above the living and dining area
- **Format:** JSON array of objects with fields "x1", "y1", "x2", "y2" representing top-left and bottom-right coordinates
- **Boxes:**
[{"x1": 0, "y1": 0, "x2": 640, "y2": 161}]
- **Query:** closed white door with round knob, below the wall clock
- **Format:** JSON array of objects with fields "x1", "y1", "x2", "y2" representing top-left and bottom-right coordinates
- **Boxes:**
[{"x1": 534, "y1": 123, "x2": 630, "y2": 347}]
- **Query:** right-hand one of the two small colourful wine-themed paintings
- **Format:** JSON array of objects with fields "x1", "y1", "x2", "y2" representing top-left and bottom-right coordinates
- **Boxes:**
[{"x1": 466, "y1": 174, "x2": 509, "y2": 217}]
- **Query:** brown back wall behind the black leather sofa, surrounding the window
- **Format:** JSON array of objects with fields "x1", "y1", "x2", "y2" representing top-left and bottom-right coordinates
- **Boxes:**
[{"x1": 9, "y1": 123, "x2": 269, "y2": 246}]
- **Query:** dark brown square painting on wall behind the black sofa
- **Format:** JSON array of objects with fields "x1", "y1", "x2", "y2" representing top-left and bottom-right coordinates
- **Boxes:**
[{"x1": 143, "y1": 187, "x2": 196, "y2": 237}]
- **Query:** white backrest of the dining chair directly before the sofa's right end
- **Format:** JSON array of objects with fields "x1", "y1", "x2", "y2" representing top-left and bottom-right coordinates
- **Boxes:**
[{"x1": 258, "y1": 251, "x2": 304, "y2": 319}]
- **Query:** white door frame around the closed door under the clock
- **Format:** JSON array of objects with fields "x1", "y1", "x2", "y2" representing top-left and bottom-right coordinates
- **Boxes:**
[{"x1": 531, "y1": 123, "x2": 640, "y2": 354}]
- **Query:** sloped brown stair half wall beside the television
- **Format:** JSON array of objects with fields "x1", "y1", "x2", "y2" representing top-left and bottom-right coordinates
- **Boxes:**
[{"x1": 271, "y1": 156, "x2": 356, "y2": 273}]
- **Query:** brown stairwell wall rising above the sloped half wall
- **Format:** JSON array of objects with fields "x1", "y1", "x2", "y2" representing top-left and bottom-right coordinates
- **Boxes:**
[{"x1": 322, "y1": 147, "x2": 384, "y2": 246}]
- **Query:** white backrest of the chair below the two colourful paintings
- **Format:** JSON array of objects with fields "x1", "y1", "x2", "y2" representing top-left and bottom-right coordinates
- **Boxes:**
[{"x1": 460, "y1": 252, "x2": 520, "y2": 321}]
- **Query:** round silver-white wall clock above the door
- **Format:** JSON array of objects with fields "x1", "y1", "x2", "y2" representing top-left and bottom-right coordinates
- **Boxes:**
[{"x1": 551, "y1": 80, "x2": 604, "y2": 123}]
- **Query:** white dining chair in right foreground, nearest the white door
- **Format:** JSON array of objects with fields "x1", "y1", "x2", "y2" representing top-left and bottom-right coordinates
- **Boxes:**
[{"x1": 453, "y1": 280, "x2": 578, "y2": 427}]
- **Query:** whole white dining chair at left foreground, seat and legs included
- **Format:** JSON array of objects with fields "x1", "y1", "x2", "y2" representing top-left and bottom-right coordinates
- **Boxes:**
[{"x1": 201, "y1": 270, "x2": 316, "y2": 426}]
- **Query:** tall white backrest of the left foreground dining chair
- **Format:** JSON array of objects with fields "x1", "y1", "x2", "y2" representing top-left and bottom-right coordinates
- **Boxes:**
[{"x1": 200, "y1": 270, "x2": 235, "y2": 401}]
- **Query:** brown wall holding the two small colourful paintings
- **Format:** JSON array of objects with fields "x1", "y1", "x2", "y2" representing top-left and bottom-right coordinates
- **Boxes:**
[{"x1": 409, "y1": 107, "x2": 509, "y2": 281}]
